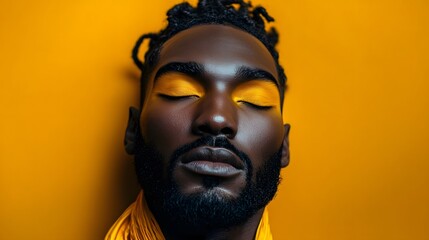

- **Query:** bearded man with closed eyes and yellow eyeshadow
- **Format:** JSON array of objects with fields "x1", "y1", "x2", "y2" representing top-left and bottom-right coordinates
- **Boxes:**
[{"x1": 106, "y1": 0, "x2": 289, "y2": 240}]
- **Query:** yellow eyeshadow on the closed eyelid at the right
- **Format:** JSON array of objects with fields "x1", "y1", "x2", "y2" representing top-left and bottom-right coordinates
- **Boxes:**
[{"x1": 232, "y1": 80, "x2": 280, "y2": 111}]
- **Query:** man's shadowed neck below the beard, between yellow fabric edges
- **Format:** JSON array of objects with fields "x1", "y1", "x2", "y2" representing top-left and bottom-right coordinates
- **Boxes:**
[{"x1": 157, "y1": 208, "x2": 264, "y2": 240}]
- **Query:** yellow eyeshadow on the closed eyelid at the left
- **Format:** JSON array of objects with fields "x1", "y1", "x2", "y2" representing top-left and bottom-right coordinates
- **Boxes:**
[{"x1": 154, "y1": 73, "x2": 204, "y2": 97}]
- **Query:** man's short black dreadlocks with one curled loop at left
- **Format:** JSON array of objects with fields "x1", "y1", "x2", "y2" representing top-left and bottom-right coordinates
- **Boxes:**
[{"x1": 132, "y1": 0, "x2": 287, "y2": 104}]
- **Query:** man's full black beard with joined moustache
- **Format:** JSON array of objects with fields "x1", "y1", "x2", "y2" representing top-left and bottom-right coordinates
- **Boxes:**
[{"x1": 135, "y1": 136, "x2": 281, "y2": 232}]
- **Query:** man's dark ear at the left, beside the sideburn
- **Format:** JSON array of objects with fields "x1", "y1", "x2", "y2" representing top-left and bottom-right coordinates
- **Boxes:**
[{"x1": 124, "y1": 107, "x2": 140, "y2": 155}]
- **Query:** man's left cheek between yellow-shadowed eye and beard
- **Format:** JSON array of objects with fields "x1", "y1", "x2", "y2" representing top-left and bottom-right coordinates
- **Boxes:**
[{"x1": 140, "y1": 101, "x2": 191, "y2": 157}]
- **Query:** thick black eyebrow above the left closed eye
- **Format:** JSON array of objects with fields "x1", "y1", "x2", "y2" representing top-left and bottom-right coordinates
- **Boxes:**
[{"x1": 155, "y1": 62, "x2": 204, "y2": 81}]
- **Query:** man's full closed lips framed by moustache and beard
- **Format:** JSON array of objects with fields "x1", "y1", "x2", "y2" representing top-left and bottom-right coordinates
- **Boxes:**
[{"x1": 181, "y1": 147, "x2": 244, "y2": 177}]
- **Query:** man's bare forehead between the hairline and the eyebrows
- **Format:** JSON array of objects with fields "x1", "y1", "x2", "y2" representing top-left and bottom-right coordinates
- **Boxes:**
[{"x1": 155, "y1": 25, "x2": 278, "y2": 82}]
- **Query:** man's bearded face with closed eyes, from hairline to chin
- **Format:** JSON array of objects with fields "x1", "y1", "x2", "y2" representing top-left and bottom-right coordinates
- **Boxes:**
[{"x1": 136, "y1": 25, "x2": 287, "y2": 230}]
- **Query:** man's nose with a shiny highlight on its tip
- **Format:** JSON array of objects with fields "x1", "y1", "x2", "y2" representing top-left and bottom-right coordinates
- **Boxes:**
[{"x1": 192, "y1": 94, "x2": 237, "y2": 139}]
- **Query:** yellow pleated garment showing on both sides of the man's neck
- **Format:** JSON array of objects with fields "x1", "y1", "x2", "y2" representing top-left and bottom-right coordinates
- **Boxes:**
[{"x1": 105, "y1": 191, "x2": 273, "y2": 240}]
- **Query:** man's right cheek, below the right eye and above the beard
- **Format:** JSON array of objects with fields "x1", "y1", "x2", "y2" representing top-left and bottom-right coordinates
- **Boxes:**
[{"x1": 236, "y1": 114, "x2": 284, "y2": 169}]
